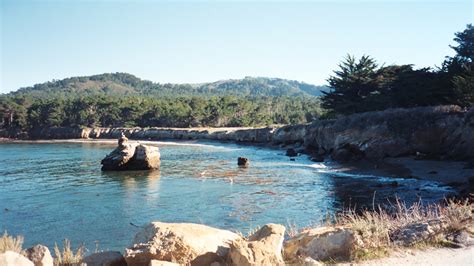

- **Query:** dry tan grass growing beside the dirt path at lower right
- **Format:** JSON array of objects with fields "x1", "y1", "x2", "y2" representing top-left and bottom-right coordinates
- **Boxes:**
[{"x1": 335, "y1": 200, "x2": 474, "y2": 260}]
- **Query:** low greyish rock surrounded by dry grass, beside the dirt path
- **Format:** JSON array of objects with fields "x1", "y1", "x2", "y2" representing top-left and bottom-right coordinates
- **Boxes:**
[{"x1": 390, "y1": 220, "x2": 444, "y2": 246}]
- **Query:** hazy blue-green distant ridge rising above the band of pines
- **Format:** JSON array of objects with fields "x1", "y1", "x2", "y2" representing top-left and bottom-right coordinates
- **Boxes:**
[{"x1": 9, "y1": 73, "x2": 328, "y2": 98}]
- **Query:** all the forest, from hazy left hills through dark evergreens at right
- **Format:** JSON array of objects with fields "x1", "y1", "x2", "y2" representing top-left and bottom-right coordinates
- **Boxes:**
[{"x1": 0, "y1": 25, "x2": 474, "y2": 131}]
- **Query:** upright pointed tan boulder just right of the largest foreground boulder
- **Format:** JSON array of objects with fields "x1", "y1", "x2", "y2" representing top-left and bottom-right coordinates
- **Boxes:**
[{"x1": 229, "y1": 224, "x2": 285, "y2": 266}]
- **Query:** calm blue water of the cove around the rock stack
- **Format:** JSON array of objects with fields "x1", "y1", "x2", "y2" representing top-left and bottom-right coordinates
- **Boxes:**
[{"x1": 0, "y1": 142, "x2": 449, "y2": 250}]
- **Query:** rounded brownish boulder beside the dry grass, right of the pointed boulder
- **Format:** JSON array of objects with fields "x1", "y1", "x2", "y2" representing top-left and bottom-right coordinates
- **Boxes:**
[{"x1": 284, "y1": 227, "x2": 356, "y2": 261}]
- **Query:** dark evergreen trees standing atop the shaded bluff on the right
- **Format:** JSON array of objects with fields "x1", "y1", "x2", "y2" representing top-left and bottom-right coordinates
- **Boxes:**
[{"x1": 321, "y1": 24, "x2": 474, "y2": 116}]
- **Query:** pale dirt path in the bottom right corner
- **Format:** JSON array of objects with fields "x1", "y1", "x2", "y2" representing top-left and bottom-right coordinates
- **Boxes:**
[{"x1": 356, "y1": 246, "x2": 474, "y2": 266}]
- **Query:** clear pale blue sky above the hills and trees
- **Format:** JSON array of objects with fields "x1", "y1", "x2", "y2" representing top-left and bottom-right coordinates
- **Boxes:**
[{"x1": 0, "y1": 0, "x2": 474, "y2": 93}]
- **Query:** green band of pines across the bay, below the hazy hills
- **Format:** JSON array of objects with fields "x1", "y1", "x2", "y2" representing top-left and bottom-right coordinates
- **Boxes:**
[{"x1": 0, "y1": 95, "x2": 321, "y2": 131}]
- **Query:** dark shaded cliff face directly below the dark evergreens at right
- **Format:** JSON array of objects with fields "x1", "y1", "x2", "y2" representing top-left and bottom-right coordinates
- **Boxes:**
[{"x1": 304, "y1": 106, "x2": 474, "y2": 161}]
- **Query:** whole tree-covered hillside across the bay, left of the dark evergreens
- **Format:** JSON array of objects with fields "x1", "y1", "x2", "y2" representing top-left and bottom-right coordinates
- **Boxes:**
[{"x1": 0, "y1": 73, "x2": 326, "y2": 131}]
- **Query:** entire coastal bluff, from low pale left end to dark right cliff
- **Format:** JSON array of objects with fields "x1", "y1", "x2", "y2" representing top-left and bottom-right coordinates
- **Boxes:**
[{"x1": 0, "y1": 106, "x2": 474, "y2": 162}]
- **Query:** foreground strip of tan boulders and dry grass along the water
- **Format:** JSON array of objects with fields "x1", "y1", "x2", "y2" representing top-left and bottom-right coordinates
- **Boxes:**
[{"x1": 0, "y1": 202, "x2": 474, "y2": 266}]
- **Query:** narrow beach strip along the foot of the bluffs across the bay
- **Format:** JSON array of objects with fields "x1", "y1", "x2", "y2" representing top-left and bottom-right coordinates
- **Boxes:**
[{"x1": 0, "y1": 138, "x2": 474, "y2": 197}]
